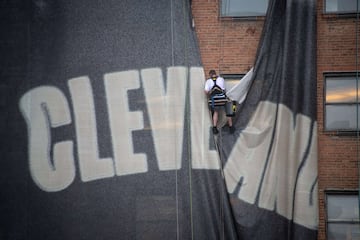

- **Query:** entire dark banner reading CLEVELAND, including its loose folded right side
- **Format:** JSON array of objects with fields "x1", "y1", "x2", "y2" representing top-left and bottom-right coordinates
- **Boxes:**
[{"x1": 0, "y1": 0, "x2": 317, "y2": 240}]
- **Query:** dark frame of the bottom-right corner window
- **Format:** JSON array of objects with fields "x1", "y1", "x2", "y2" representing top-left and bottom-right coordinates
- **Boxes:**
[{"x1": 324, "y1": 189, "x2": 360, "y2": 239}]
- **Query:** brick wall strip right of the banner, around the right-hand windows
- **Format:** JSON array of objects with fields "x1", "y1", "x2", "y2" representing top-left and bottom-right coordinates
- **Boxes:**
[{"x1": 317, "y1": 1, "x2": 360, "y2": 240}]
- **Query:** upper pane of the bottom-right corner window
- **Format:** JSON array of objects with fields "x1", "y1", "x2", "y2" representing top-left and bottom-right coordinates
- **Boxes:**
[{"x1": 327, "y1": 194, "x2": 359, "y2": 221}]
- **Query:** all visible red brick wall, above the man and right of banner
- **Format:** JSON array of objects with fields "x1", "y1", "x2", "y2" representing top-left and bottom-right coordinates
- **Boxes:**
[{"x1": 192, "y1": 0, "x2": 360, "y2": 240}]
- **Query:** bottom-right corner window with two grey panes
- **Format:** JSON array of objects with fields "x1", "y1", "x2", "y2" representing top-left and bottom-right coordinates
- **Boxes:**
[{"x1": 326, "y1": 191, "x2": 360, "y2": 240}]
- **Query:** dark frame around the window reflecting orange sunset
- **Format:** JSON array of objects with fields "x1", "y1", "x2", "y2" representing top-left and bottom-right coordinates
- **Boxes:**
[{"x1": 323, "y1": 72, "x2": 360, "y2": 135}]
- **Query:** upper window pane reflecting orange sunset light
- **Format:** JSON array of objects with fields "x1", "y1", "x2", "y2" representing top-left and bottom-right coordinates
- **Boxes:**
[{"x1": 326, "y1": 77, "x2": 360, "y2": 103}]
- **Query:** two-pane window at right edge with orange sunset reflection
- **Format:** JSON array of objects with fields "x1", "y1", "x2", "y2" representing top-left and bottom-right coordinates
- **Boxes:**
[{"x1": 324, "y1": 73, "x2": 360, "y2": 131}]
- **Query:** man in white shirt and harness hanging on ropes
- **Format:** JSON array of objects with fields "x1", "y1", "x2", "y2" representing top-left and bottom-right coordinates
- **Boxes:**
[{"x1": 205, "y1": 70, "x2": 235, "y2": 134}]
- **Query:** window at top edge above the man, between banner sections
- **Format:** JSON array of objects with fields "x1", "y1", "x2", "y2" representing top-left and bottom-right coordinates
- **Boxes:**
[{"x1": 221, "y1": 0, "x2": 268, "y2": 17}]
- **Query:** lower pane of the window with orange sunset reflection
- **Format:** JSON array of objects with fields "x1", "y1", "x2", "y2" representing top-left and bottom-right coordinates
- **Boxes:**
[{"x1": 325, "y1": 104, "x2": 360, "y2": 130}]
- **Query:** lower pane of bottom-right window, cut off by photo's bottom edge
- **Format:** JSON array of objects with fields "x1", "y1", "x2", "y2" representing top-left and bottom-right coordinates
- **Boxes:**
[{"x1": 327, "y1": 223, "x2": 360, "y2": 240}]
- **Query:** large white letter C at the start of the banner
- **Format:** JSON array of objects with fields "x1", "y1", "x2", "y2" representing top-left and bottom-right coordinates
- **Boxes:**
[{"x1": 19, "y1": 87, "x2": 75, "y2": 192}]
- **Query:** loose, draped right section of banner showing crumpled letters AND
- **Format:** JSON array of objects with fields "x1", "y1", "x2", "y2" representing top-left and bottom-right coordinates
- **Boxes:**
[{"x1": 225, "y1": 0, "x2": 318, "y2": 239}]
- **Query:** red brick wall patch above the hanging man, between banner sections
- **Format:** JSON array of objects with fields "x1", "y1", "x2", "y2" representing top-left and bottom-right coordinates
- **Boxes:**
[{"x1": 192, "y1": 0, "x2": 264, "y2": 74}]
